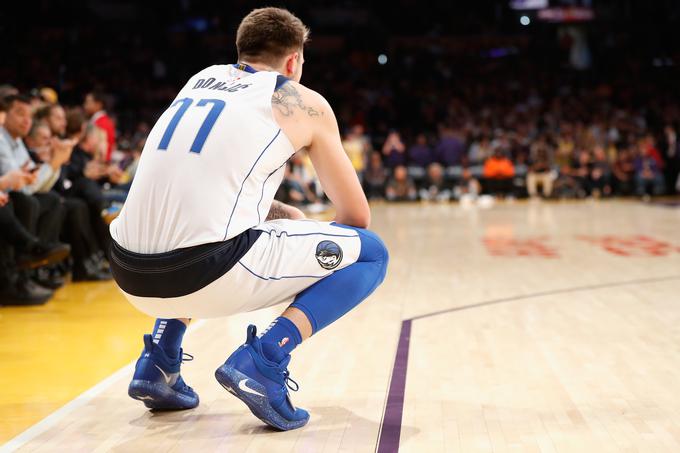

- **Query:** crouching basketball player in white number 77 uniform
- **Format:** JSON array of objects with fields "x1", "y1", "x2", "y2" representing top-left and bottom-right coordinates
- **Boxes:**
[{"x1": 111, "y1": 8, "x2": 388, "y2": 430}]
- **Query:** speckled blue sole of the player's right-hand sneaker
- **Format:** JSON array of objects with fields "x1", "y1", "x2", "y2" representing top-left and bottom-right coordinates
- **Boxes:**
[{"x1": 215, "y1": 365, "x2": 309, "y2": 431}]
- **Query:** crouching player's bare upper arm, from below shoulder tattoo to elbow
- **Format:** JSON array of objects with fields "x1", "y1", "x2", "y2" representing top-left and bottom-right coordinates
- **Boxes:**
[{"x1": 308, "y1": 92, "x2": 371, "y2": 228}]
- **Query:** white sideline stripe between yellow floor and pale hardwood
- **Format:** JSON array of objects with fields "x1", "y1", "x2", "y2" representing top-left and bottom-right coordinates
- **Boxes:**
[{"x1": 0, "y1": 319, "x2": 205, "y2": 453}]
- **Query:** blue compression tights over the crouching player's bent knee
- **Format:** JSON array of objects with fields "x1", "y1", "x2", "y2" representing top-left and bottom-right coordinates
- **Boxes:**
[{"x1": 291, "y1": 224, "x2": 389, "y2": 333}]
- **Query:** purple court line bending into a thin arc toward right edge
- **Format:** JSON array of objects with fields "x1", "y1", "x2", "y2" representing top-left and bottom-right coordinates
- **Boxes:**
[{"x1": 376, "y1": 275, "x2": 680, "y2": 453}]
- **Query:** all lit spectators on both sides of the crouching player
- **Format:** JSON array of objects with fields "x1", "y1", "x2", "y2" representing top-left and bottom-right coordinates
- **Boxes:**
[{"x1": 0, "y1": 69, "x2": 680, "y2": 304}]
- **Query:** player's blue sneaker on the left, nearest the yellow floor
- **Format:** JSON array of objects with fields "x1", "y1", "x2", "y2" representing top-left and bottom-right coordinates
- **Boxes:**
[{"x1": 128, "y1": 335, "x2": 198, "y2": 410}]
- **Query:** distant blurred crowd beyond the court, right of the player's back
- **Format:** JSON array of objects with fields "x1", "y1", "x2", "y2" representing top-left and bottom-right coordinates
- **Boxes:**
[{"x1": 281, "y1": 102, "x2": 680, "y2": 203}]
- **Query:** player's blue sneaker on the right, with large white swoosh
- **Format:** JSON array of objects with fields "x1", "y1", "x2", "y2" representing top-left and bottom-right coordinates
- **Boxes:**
[{"x1": 215, "y1": 325, "x2": 309, "y2": 431}]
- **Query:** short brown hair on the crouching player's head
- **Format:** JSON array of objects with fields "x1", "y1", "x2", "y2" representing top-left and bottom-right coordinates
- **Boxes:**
[{"x1": 236, "y1": 8, "x2": 309, "y2": 64}]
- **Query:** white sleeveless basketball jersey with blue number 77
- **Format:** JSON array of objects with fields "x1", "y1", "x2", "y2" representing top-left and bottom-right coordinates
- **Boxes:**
[{"x1": 111, "y1": 65, "x2": 295, "y2": 254}]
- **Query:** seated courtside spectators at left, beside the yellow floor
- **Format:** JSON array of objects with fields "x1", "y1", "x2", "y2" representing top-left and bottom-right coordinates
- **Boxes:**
[{"x1": 0, "y1": 85, "x2": 142, "y2": 305}]
